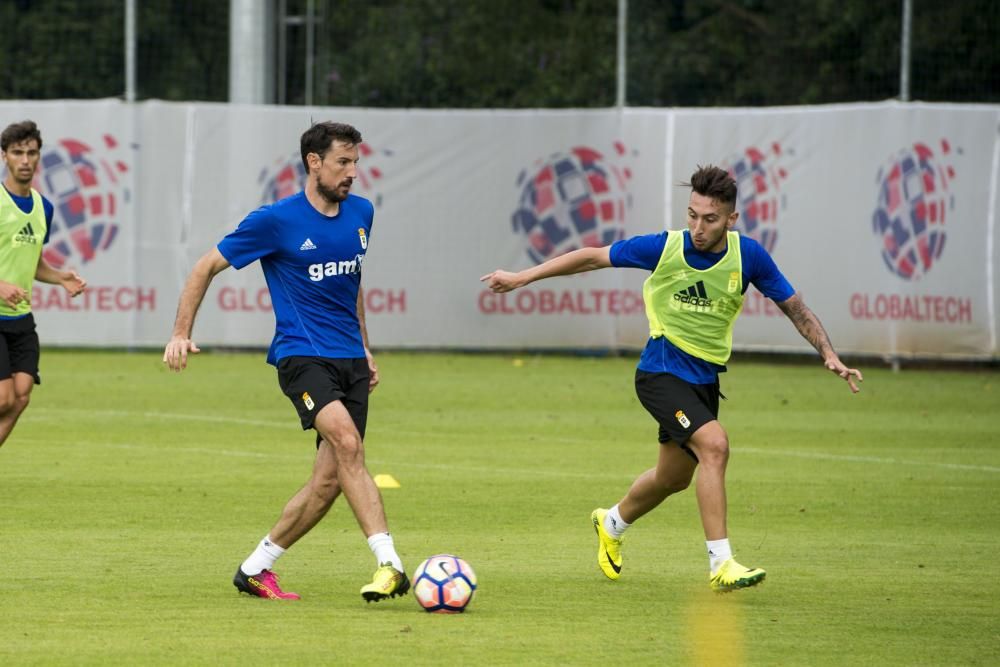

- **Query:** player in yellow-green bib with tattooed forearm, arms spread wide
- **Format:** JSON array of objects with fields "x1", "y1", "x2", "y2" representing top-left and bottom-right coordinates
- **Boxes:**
[{"x1": 482, "y1": 166, "x2": 862, "y2": 592}]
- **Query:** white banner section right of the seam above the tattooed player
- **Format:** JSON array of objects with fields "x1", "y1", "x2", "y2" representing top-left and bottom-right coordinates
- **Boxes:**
[{"x1": 674, "y1": 104, "x2": 1000, "y2": 357}]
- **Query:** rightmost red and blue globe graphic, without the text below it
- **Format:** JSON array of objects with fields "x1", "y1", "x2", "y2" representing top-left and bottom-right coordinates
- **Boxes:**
[{"x1": 872, "y1": 140, "x2": 955, "y2": 280}]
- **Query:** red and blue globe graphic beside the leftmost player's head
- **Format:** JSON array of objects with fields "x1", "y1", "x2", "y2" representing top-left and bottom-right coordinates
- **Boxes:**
[{"x1": 34, "y1": 134, "x2": 130, "y2": 268}]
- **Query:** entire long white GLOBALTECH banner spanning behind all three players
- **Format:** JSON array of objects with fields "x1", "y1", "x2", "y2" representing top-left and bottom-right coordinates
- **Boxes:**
[{"x1": 0, "y1": 100, "x2": 1000, "y2": 358}]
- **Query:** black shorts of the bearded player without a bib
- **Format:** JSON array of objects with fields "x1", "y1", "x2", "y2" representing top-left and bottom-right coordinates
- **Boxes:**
[{"x1": 278, "y1": 357, "x2": 369, "y2": 442}]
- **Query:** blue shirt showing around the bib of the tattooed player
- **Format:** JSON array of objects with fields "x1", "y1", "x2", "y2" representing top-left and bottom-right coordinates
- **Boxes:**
[{"x1": 611, "y1": 231, "x2": 795, "y2": 384}]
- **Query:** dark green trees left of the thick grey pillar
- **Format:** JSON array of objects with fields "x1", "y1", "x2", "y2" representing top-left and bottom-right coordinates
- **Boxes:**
[{"x1": 0, "y1": 0, "x2": 229, "y2": 102}]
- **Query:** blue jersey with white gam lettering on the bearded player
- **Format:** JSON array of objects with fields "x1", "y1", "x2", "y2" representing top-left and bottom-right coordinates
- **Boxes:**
[{"x1": 218, "y1": 192, "x2": 375, "y2": 365}]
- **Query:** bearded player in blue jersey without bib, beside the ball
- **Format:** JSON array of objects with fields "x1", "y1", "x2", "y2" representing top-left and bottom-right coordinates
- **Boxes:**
[{"x1": 163, "y1": 122, "x2": 410, "y2": 602}]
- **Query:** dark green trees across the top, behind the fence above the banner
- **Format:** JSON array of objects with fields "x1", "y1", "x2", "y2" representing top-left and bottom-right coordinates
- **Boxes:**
[{"x1": 0, "y1": 0, "x2": 1000, "y2": 108}]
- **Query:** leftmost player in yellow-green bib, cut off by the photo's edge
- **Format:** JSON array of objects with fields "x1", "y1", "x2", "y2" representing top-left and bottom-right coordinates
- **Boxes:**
[{"x1": 0, "y1": 120, "x2": 87, "y2": 454}]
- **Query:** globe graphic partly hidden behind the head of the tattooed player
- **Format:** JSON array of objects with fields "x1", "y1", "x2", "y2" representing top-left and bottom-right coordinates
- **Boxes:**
[{"x1": 726, "y1": 142, "x2": 788, "y2": 252}]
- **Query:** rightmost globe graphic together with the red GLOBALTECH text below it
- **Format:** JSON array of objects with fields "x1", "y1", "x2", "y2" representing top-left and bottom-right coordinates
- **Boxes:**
[{"x1": 850, "y1": 138, "x2": 972, "y2": 324}]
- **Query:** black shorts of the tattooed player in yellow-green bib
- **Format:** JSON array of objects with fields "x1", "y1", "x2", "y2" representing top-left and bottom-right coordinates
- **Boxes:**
[{"x1": 635, "y1": 370, "x2": 722, "y2": 460}]
